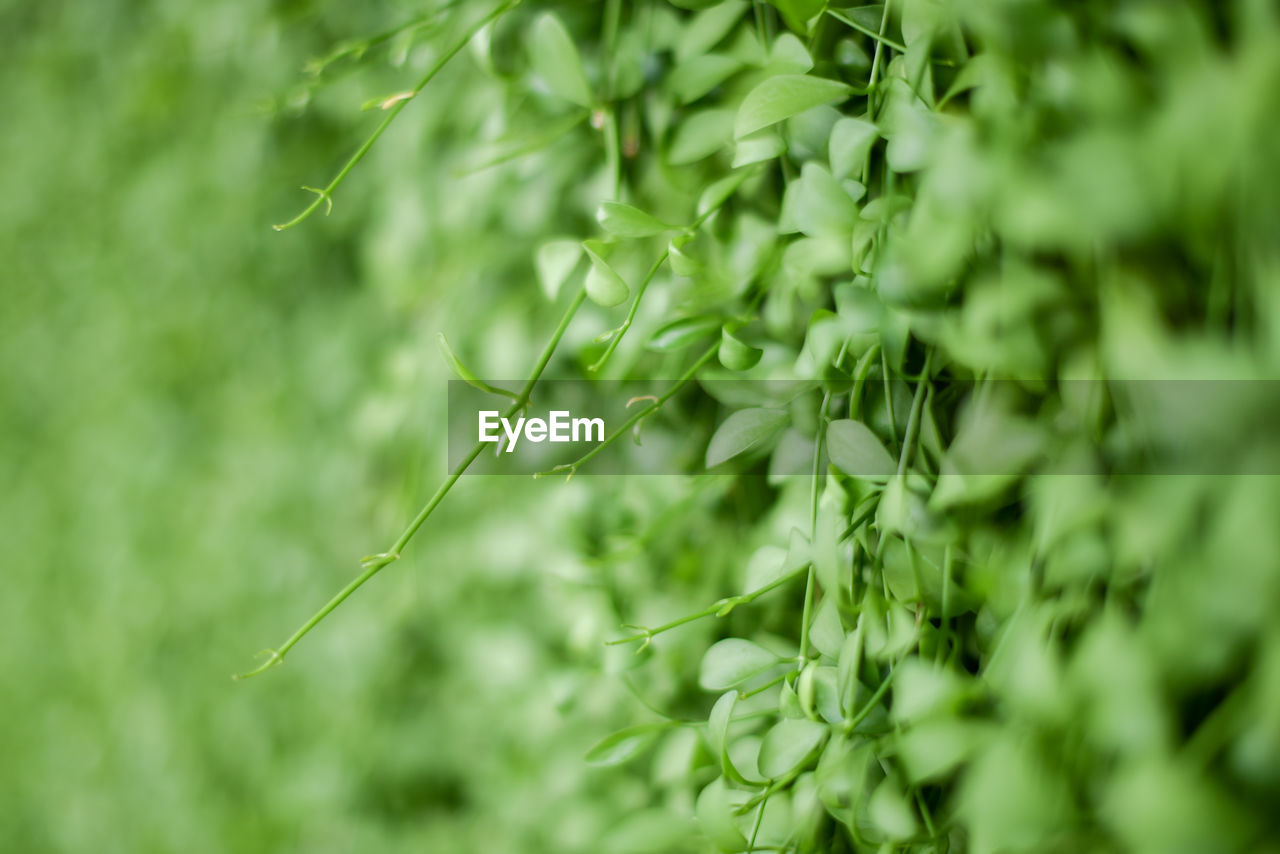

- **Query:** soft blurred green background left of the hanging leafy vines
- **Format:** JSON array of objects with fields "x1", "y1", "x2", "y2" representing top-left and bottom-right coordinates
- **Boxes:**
[{"x1": 0, "y1": 0, "x2": 706, "y2": 853}]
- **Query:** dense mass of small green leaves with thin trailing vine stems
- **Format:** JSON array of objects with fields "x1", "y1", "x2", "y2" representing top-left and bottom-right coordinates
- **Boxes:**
[{"x1": 269, "y1": 0, "x2": 1280, "y2": 851}]
